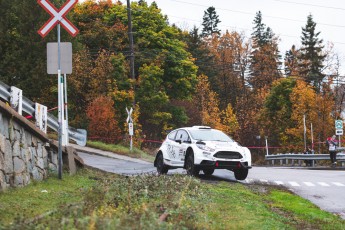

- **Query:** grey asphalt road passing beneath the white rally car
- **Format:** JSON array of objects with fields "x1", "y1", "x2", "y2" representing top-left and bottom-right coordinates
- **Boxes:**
[{"x1": 78, "y1": 152, "x2": 345, "y2": 219}]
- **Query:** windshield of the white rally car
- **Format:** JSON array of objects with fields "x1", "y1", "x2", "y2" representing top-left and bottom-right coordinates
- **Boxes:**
[{"x1": 189, "y1": 129, "x2": 233, "y2": 142}]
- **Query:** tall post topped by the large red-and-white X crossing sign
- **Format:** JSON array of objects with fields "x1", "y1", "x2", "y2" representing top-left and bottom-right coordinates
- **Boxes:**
[{"x1": 37, "y1": 0, "x2": 79, "y2": 179}]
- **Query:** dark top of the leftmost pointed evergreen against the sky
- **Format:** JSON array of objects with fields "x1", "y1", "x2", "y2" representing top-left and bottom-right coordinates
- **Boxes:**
[{"x1": 201, "y1": 6, "x2": 221, "y2": 37}]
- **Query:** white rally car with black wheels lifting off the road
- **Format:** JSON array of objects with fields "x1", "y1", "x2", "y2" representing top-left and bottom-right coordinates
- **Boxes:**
[{"x1": 154, "y1": 126, "x2": 252, "y2": 180}]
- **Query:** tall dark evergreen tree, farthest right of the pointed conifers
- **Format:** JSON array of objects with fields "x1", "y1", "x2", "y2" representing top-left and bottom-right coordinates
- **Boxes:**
[{"x1": 299, "y1": 15, "x2": 326, "y2": 91}]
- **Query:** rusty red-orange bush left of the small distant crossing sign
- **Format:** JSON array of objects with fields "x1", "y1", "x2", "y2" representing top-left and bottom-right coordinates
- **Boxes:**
[{"x1": 86, "y1": 96, "x2": 121, "y2": 143}]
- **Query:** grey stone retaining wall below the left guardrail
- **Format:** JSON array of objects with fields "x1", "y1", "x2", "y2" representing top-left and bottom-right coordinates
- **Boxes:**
[{"x1": 0, "y1": 101, "x2": 58, "y2": 191}]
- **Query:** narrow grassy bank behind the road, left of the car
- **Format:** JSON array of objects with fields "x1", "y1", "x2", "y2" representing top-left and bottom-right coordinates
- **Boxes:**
[{"x1": 87, "y1": 141, "x2": 154, "y2": 162}]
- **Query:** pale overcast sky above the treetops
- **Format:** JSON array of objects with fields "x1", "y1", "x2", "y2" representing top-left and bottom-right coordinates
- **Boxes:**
[{"x1": 140, "y1": 0, "x2": 345, "y2": 76}]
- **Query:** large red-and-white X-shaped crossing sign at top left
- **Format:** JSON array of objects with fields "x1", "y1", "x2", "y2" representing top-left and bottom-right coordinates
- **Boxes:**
[{"x1": 37, "y1": 0, "x2": 79, "y2": 38}]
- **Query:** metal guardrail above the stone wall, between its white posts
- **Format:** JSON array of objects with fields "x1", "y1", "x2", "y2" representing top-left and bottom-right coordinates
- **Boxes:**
[{"x1": 0, "y1": 81, "x2": 87, "y2": 146}]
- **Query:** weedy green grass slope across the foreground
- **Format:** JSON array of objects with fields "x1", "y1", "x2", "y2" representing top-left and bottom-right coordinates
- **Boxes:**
[{"x1": 0, "y1": 169, "x2": 345, "y2": 229}]
